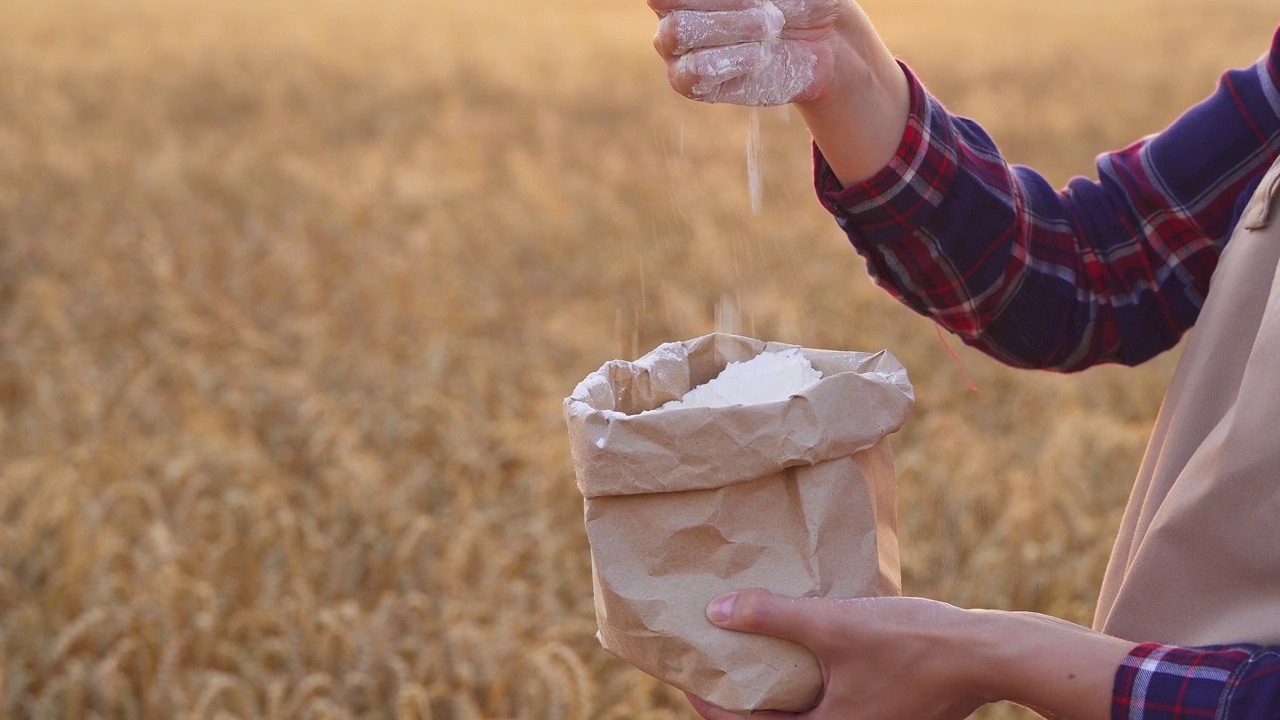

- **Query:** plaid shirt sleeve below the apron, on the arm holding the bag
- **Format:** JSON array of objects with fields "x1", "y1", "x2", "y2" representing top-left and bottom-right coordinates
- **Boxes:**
[{"x1": 1111, "y1": 644, "x2": 1280, "y2": 720}]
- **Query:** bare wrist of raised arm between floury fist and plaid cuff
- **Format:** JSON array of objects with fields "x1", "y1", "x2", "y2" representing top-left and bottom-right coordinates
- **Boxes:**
[{"x1": 796, "y1": 4, "x2": 910, "y2": 187}]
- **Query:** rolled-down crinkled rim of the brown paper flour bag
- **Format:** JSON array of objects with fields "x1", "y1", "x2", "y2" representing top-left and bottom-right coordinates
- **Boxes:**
[{"x1": 564, "y1": 333, "x2": 915, "y2": 498}]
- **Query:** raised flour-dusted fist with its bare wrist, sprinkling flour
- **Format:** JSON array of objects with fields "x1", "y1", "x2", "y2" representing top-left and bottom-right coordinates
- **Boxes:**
[{"x1": 649, "y1": 0, "x2": 910, "y2": 184}]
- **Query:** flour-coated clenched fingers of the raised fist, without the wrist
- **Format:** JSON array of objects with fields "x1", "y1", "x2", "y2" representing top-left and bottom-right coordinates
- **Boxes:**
[{"x1": 649, "y1": 0, "x2": 849, "y2": 106}]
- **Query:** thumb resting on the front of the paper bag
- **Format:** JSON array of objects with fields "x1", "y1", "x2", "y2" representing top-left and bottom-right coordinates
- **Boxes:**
[{"x1": 707, "y1": 589, "x2": 832, "y2": 650}]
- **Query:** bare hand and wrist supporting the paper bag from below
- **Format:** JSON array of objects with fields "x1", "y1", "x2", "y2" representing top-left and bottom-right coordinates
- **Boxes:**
[{"x1": 690, "y1": 591, "x2": 1133, "y2": 720}]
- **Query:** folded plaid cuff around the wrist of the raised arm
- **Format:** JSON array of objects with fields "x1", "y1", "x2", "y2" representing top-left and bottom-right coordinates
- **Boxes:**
[{"x1": 813, "y1": 63, "x2": 956, "y2": 245}]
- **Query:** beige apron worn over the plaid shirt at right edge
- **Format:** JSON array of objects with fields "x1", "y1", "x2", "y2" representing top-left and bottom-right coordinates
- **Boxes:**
[{"x1": 1093, "y1": 152, "x2": 1280, "y2": 646}]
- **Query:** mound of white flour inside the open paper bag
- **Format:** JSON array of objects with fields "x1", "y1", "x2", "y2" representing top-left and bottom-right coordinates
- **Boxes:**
[{"x1": 662, "y1": 348, "x2": 822, "y2": 410}]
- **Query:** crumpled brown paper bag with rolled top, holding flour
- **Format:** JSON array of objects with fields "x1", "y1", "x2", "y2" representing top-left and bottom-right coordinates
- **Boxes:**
[{"x1": 564, "y1": 334, "x2": 914, "y2": 712}]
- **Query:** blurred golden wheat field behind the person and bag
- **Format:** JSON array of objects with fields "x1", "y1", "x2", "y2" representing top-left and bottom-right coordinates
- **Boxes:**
[{"x1": 0, "y1": 0, "x2": 1276, "y2": 720}]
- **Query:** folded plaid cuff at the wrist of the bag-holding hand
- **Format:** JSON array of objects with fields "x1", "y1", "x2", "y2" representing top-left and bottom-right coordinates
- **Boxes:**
[{"x1": 1111, "y1": 643, "x2": 1251, "y2": 720}]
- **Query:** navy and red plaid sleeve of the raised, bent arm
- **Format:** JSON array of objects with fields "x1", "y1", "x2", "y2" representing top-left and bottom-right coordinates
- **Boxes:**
[{"x1": 815, "y1": 28, "x2": 1280, "y2": 372}]
